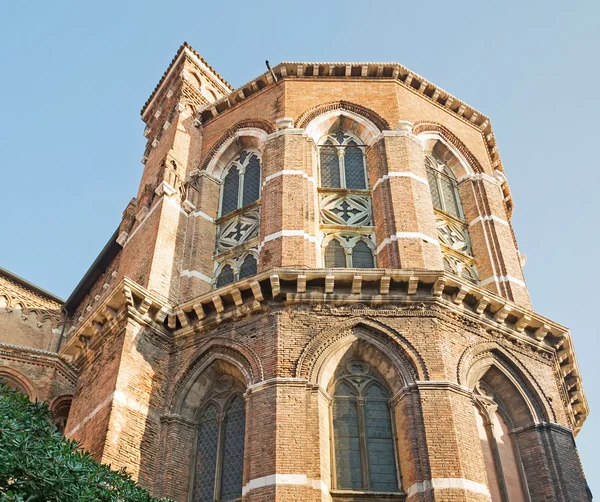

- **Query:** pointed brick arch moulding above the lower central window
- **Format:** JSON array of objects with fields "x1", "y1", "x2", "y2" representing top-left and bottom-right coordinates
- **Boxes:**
[{"x1": 296, "y1": 317, "x2": 428, "y2": 392}]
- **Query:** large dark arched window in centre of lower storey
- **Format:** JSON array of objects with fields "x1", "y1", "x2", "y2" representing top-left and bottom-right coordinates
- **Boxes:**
[{"x1": 330, "y1": 359, "x2": 400, "y2": 493}]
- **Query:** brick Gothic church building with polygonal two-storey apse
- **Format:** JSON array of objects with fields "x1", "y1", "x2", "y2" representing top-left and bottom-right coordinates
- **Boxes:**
[{"x1": 0, "y1": 44, "x2": 591, "y2": 502}]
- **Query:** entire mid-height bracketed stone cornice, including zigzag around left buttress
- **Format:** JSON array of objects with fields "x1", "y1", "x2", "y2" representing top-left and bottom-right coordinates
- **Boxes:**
[{"x1": 54, "y1": 268, "x2": 589, "y2": 432}]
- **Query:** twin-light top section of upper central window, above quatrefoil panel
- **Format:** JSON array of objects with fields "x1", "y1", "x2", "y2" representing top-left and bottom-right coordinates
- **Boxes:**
[{"x1": 319, "y1": 130, "x2": 367, "y2": 190}]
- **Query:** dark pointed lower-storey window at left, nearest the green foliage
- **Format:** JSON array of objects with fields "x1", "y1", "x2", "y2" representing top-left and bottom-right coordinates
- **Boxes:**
[{"x1": 192, "y1": 376, "x2": 246, "y2": 502}]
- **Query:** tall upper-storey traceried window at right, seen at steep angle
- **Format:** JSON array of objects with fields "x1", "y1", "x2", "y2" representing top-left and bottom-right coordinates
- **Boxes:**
[{"x1": 425, "y1": 153, "x2": 479, "y2": 282}]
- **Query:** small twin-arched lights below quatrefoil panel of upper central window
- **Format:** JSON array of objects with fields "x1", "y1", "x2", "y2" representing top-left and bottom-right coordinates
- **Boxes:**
[{"x1": 323, "y1": 234, "x2": 375, "y2": 268}]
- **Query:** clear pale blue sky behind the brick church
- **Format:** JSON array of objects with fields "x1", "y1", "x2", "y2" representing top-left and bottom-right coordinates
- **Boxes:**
[{"x1": 0, "y1": 0, "x2": 600, "y2": 496}]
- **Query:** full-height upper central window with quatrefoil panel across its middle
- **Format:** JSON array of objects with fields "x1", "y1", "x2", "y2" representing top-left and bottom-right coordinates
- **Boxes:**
[{"x1": 319, "y1": 129, "x2": 375, "y2": 268}]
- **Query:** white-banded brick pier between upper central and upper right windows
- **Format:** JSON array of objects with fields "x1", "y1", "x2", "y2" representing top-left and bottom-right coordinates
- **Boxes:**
[{"x1": 372, "y1": 120, "x2": 444, "y2": 270}]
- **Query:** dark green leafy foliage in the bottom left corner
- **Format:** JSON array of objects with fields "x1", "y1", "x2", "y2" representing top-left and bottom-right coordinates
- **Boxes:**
[{"x1": 0, "y1": 384, "x2": 170, "y2": 502}]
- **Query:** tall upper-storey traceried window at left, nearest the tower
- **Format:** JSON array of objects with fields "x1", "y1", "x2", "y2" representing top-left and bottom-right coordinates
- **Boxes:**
[{"x1": 213, "y1": 150, "x2": 262, "y2": 287}]
